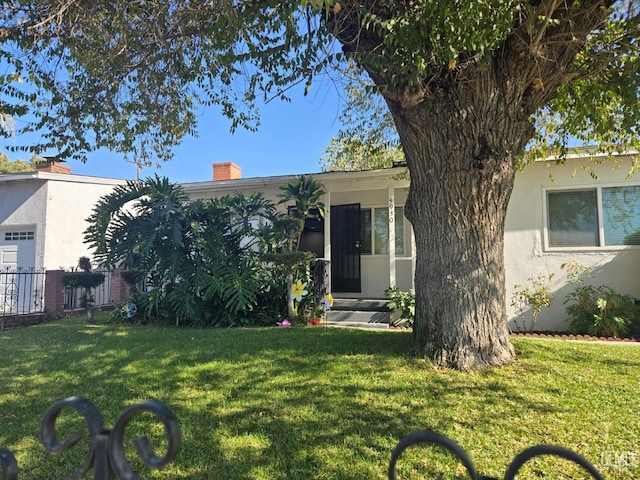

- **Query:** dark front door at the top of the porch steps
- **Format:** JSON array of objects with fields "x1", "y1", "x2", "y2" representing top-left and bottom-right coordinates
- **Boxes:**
[{"x1": 331, "y1": 203, "x2": 362, "y2": 292}]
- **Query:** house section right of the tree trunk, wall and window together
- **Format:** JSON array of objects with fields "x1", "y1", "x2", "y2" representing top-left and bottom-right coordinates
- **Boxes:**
[{"x1": 505, "y1": 149, "x2": 640, "y2": 331}]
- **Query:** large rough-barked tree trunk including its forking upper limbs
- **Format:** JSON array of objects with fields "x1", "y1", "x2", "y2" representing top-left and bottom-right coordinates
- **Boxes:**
[{"x1": 328, "y1": 0, "x2": 613, "y2": 370}]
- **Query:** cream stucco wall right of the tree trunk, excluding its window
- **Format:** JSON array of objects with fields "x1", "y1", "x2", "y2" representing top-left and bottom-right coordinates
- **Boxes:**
[{"x1": 505, "y1": 158, "x2": 640, "y2": 330}]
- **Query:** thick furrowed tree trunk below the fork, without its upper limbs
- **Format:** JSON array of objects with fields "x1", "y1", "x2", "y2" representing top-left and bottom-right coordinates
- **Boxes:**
[{"x1": 388, "y1": 69, "x2": 533, "y2": 371}]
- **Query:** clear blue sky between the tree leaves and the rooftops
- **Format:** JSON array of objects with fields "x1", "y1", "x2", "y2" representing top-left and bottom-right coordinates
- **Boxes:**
[{"x1": 2, "y1": 83, "x2": 340, "y2": 182}]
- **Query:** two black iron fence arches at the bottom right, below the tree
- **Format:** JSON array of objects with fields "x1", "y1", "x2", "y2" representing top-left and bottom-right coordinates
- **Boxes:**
[{"x1": 388, "y1": 431, "x2": 604, "y2": 480}]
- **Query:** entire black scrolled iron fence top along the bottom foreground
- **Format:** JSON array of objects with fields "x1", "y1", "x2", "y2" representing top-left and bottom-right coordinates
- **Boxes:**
[{"x1": 0, "y1": 397, "x2": 604, "y2": 480}]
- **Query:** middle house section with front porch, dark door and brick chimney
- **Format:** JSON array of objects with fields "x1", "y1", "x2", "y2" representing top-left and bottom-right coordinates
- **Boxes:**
[{"x1": 183, "y1": 164, "x2": 414, "y2": 298}]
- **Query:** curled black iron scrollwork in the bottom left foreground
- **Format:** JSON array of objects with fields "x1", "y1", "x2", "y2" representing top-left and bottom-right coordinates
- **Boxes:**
[{"x1": 0, "y1": 397, "x2": 181, "y2": 480}]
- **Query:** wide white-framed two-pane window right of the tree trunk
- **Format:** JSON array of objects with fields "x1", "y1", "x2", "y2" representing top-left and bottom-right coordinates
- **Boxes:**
[{"x1": 546, "y1": 185, "x2": 640, "y2": 248}]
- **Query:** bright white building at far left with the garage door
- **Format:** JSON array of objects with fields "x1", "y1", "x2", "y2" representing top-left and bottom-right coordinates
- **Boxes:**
[{"x1": 0, "y1": 164, "x2": 124, "y2": 270}]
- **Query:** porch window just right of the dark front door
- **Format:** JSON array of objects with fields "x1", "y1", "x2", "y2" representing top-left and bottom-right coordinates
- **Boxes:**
[{"x1": 360, "y1": 207, "x2": 407, "y2": 256}]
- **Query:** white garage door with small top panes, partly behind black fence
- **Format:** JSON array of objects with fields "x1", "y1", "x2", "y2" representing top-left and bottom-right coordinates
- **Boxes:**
[{"x1": 0, "y1": 228, "x2": 37, "y2": 314}]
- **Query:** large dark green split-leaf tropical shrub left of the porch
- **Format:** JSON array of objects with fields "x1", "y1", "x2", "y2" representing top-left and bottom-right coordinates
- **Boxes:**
[{"x1": 86, "y1": 177, "x2": 285, "y2": 326}]
